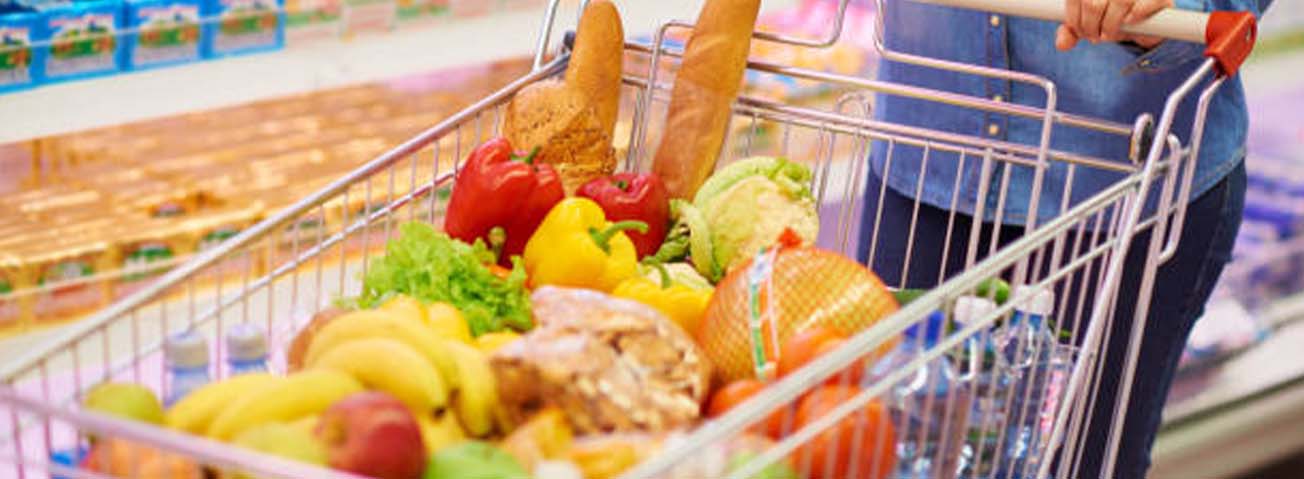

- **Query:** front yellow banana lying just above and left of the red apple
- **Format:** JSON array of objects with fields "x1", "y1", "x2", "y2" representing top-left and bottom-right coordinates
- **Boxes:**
[{"x1": 207, "y1": 369, "x2": 363, "y2": 441}]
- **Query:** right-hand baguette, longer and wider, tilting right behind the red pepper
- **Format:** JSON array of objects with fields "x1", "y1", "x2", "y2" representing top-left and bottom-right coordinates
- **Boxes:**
[{"x1": 652, "y1": 0, "x2": 760, "y2": 201}]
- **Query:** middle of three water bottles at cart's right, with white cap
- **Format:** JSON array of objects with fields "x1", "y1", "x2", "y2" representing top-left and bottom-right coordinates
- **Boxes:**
[{"x1": 953, "y1": 296, "x2": 1013, "y2": 479}]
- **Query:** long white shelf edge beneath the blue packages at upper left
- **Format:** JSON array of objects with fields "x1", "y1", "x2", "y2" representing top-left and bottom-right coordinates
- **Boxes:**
[{"x1": 0, "y1": 0, "x2": 795, "y2": 144}]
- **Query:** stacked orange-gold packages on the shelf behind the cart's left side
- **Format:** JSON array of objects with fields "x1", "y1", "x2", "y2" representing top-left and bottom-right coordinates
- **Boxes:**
[{"x1": 0, "y1": 61, "x2": 526, "y2": 333}]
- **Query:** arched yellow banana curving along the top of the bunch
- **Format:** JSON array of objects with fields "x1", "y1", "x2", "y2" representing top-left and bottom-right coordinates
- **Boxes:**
[{"x1": 304, "y1": 311, "x2": 458, "y2": 388}]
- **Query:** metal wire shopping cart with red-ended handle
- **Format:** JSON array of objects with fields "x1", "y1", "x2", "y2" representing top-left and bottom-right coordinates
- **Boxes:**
[{"x1": 0, "y1": 0, "x2": 1253, "y2": 478}]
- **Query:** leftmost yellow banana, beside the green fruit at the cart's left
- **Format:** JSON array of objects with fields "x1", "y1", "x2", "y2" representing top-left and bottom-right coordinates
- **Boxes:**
[{"x1": 164, "y1": 373, "x2": 282, "y2": 435}]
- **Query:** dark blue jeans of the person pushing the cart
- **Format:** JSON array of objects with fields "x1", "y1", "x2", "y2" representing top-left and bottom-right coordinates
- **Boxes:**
[{"x1": 859, "y1": 162, "x2": 1245, "y2": 479}]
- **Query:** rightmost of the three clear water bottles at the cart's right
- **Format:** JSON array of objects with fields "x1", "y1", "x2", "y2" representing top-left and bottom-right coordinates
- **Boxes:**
[{"x1": 994, "y1": 290, "x2": 1072, "y2": 478}]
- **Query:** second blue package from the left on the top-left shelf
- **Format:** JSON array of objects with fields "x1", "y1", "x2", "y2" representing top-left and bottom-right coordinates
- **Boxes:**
[{"x1": 34, "y1": 0, "x2": 124, "y2": 81}]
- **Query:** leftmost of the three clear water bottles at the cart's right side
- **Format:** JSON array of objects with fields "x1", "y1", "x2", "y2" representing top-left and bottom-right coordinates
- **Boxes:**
[{"x1": 871, "y1": 312, "x2": 969, "y2": 479}]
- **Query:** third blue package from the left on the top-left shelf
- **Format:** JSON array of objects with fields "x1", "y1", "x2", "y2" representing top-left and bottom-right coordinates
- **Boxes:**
[{"x1": 126, "y1": 0, "x2": 201, "y2": 69}]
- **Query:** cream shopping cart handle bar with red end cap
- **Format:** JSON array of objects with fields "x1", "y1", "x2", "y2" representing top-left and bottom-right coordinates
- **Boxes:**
[{"x1": 914, "y1": 0, "x2": 1258, "y2": 76}]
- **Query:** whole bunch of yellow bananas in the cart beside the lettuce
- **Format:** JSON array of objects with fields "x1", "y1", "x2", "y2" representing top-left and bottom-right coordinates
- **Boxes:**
[{"x1": 166, "y1": 296, "x2": 524, "y2": 450}]
